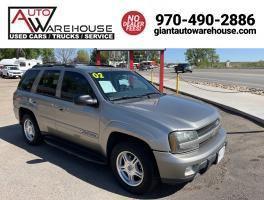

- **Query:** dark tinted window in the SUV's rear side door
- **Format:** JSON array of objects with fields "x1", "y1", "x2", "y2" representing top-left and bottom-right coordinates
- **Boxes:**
[{"x1": 37, "y1": 70, "x2": 60, "y2": 96}]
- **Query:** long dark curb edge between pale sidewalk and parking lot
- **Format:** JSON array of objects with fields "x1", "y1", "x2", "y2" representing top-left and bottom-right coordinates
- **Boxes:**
[{"x1": 153, "y1": 83, "x2": 264, "y2": 127}]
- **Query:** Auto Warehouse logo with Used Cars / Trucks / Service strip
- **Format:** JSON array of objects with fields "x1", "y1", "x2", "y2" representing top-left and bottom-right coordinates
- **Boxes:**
[{"x1": 8, "y1": 7, "x2": 115, "y2": 40}]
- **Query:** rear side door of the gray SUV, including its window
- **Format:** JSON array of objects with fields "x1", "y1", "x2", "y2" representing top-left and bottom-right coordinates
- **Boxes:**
[{"x1": 33, "y1": 70, "x2": 61, "y2": 133}]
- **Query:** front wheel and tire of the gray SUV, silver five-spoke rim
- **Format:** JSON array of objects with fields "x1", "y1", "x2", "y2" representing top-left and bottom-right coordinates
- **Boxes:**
[{"x1": 110, "y1": 143, "x2": 159, "y2": 195}]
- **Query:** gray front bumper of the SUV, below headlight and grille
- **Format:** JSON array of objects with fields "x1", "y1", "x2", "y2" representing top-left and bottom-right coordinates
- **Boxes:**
[{"x1": 153, "y1": 128, "x2": 227, "y2": 183}]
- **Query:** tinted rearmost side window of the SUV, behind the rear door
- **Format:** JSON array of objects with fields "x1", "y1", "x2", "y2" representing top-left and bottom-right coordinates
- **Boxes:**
[{"x1": 18, "y1": 70, "x2": 40, "y2": 91}]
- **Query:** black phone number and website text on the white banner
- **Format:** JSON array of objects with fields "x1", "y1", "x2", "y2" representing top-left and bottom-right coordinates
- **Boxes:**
[{"x1": 154, "y1": 13, "x2": 257, "y2": 36}]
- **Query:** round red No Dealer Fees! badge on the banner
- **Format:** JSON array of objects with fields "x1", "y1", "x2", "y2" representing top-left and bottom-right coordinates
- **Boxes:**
[{"x1": 121, "y1": 11, "x2": 146, "y2": 35}]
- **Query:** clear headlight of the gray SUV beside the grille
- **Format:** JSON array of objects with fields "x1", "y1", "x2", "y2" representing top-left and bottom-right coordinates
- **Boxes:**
[{"x1": 169, "y1": 131, "x2": 199, "y2": 153}]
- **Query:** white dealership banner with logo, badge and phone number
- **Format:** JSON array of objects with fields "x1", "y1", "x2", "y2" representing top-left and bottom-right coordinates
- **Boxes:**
[{"x1": 0, "y1": 0, "x2": 264, "y2": 48}]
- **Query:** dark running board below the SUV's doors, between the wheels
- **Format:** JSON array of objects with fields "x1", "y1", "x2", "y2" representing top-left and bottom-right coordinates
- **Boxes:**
[{"x1": 44, "y1": 136, "x2": 107, "y2": 165}]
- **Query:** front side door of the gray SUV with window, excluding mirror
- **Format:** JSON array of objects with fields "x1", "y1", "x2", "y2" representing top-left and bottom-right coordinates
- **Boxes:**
[{"x1": 56, "y1": 71, "x2": 99, "y2": 148}]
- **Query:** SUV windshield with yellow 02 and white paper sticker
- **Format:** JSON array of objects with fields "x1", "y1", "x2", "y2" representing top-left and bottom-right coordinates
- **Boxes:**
[{"x1": 90, "y1": 71, "x2": 161, "y2": 101}]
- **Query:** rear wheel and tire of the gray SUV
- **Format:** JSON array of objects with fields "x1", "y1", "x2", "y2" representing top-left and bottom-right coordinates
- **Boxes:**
[{"x1": 22, "y1": 114, "x2": 42, "y2": 145}]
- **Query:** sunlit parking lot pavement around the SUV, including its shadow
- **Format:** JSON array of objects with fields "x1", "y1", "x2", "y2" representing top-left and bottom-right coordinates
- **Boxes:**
[{"x1": 0, "y1": 79, "x2": 264, "y2": 200}]
